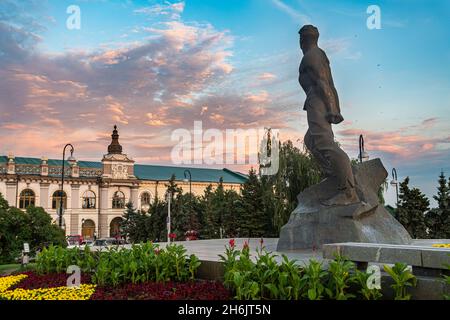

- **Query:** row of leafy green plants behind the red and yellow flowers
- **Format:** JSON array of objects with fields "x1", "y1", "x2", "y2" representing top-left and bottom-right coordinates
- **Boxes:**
[{"x1": 36, "y1": 243, "x2": 200, "y2": 287}]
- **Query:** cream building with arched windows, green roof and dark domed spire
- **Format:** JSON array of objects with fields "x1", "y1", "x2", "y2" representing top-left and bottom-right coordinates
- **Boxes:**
[{"x1": 0, "y1": 127, "x2": 246, "y2": 238}]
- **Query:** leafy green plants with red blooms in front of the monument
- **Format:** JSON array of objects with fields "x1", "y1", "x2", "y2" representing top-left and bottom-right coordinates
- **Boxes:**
[{"x1": 220, "y1": 240, "x2": 424, "y2": 300}]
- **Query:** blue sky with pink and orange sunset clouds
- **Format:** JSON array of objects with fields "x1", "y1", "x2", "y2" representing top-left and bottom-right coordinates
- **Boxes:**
[{"x1": 0, "y1": 0, "x2": 450, "y2": 203}]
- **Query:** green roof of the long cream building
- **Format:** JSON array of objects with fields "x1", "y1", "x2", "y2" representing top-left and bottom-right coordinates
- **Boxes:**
[{"x1": 0, "y1": 156, "x2": 247, "y2": 184}]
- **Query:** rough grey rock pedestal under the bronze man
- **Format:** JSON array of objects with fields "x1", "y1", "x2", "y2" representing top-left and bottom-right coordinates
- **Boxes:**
[{"x1": 277, "y1": 159, "x2": 412, "y2": 251}]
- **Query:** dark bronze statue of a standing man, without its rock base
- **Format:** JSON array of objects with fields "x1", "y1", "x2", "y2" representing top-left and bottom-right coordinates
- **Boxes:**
[{"x1": 299, "y1": 25, "x2": 359, "y2": 206}]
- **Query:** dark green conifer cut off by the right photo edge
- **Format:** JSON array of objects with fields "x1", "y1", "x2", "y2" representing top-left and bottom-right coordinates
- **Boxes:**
[{"x1": 426, "y1": 172, "x2": 450, "y2": 239}]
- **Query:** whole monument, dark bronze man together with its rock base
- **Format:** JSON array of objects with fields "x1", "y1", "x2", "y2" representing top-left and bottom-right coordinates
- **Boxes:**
[{"x1": 278, "y1": 25, "x2": 411, "y2": 251}]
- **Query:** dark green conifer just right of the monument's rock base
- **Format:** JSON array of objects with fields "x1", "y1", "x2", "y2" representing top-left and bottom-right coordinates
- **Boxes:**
[{"x1": 396, "y1": 177, "x2": 430, "y2": 239}]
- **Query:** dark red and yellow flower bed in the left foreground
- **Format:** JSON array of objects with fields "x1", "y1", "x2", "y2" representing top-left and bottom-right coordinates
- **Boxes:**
[{"x1": 0, "y1": 272, "x2": 231, "y2": 300}]
